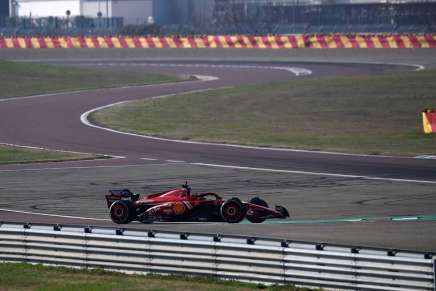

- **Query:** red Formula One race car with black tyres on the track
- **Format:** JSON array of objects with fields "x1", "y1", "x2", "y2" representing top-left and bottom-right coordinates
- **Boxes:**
[{"x1": 106, "y1": 183, "x2": 289, "y2": 224}]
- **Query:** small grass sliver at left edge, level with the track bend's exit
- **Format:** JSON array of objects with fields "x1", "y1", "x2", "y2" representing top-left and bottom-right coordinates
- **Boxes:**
[{"x1": 0, "y1": 145, "x2": 96, "y2": 164}]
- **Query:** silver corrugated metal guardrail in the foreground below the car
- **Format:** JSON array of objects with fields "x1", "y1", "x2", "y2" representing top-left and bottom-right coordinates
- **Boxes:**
[{"x1": 0, "y1": 223, "x2": 436, "y2": 291}]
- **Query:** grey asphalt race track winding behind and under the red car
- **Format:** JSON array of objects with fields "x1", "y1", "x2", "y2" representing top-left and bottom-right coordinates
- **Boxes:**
[{"x1": 0, "y1": 50, "x2": 436, "y2": 251}]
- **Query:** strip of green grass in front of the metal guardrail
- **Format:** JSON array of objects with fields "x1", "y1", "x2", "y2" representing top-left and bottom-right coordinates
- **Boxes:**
[{"x1": 0, "y1": 263, "x2": 311, "y2": 291}]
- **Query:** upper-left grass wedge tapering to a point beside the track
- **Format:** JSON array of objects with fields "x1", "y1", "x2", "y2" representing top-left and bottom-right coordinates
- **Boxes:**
[{"x1": 0, "y1": 60, "x2": 181, "y2": 98}]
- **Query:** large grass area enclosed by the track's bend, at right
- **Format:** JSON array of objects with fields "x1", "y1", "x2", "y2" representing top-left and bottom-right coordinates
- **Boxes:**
[{"x1": 91, "y1": 70, "x2": 436, "y2": 155}]
